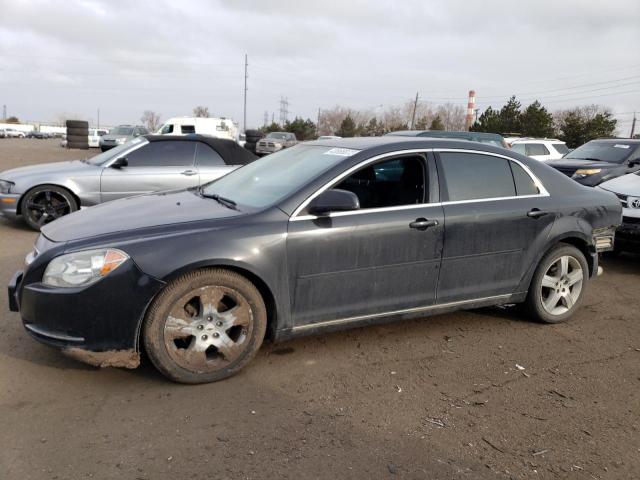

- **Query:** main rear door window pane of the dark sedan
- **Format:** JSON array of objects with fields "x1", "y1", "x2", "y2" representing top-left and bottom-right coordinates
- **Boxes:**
[{"x1": 440, "y1": 152, "x2": 516, "y2": 202}]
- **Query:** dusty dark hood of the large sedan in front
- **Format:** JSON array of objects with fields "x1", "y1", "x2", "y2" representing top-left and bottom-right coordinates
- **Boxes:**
[{"x1": 42, "y1": 190, "x2": 244, "y2": 242}]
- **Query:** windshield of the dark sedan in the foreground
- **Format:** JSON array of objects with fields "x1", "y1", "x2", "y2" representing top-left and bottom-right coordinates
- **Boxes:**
[{"x1": 203, "y1": 145, "x2": 357, "y2": 208}]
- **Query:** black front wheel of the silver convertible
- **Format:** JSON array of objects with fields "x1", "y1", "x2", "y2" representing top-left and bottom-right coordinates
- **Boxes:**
[{"x1": 21, "y1": 185, "x2": 78, "y2": 230}]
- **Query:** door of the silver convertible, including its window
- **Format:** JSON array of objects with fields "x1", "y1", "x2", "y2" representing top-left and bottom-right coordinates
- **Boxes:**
[{"x1": 100, "y1": 140, "x2": 199, "y2": 202}]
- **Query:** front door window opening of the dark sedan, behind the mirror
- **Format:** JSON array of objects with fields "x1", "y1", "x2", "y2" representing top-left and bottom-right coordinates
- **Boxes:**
[{"x1": 333, "y1": 156, "x2": 425, "y2": 208}]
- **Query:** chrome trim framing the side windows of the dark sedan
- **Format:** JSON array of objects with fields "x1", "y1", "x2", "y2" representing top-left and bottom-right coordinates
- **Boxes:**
[{"x1": 289, "y1": 148, "x2": 549, "y2": 222}]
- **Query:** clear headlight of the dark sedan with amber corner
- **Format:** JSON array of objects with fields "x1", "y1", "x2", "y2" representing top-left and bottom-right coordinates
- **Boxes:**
[{"x1": 42, "y1": 248, "x2": 129, "y2": 287}]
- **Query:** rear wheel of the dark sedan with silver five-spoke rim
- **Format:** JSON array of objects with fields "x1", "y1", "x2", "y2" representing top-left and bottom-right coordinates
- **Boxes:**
[{"x1": 525, "y1": 244, "x2": 589, "y2": 323}]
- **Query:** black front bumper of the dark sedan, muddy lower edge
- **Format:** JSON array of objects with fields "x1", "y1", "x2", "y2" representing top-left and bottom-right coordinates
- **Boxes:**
[{"x1": 8, "y1": 260, "x2": 164, "y2": 358}]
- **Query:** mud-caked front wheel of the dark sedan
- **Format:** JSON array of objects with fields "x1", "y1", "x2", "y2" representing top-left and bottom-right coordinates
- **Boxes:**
[{"x1": 142, "y1": 268, "x2": 267, "y2": 384}]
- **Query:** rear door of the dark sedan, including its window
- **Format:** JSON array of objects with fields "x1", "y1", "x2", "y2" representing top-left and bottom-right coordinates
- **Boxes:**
[{"x1": 437, "y1": 150, "x2": 555, "y2": 303}]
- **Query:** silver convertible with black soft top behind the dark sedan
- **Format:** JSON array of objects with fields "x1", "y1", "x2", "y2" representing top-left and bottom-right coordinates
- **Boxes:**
[{"x1": 0, "y1": 135, "x2": 256, "y2": 230}]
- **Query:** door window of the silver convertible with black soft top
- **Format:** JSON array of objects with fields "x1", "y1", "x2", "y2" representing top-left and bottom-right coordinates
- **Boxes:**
[{"x1": 127, "y1": 141, "x2": 196, "y2": 167}]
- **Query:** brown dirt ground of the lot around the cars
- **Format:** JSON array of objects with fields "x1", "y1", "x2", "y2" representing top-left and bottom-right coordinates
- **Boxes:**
[{"x1": 0, "y1": 139, "x2": 640, "y2": 480}]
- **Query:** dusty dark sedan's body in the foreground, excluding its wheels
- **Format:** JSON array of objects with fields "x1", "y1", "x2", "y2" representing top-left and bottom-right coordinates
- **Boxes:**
[{"x1": 9, "y1": 137, "x2": 621, "y2": 374}]
